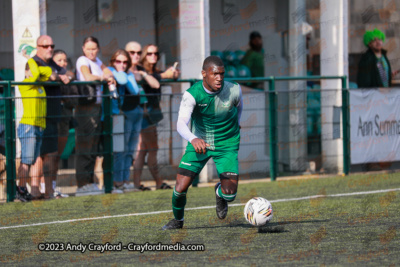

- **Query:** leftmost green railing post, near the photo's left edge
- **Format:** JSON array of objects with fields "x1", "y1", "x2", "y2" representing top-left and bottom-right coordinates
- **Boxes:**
[{"x1": 4, "y1": 81, "x2": 17, "y2": 202}]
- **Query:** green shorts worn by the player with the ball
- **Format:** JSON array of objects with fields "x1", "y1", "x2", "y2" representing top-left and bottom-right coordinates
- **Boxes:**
[{"x1": 179, "y1": 150, "x2": 239, "y2": 176}]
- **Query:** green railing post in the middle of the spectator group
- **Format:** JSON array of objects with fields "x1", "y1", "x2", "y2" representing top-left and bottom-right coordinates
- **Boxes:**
[{"x1": 103, "y1": 83, "x2": 114, "y2": 193}]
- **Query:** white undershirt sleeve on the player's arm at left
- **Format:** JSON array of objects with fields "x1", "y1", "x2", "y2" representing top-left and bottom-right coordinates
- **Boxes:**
[{"x1": 176, "y1": 91, "x2": 198, "y2": 142}]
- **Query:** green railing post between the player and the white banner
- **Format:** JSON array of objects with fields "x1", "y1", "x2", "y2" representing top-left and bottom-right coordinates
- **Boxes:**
[{"x1": 268, "y1": 77, "x2": 277, "y2": 181}]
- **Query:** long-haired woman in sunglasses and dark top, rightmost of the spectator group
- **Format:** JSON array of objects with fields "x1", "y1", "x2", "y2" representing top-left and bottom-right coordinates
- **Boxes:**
[{"x1": 133, "y1": 44, "x2": 178, "y2": 191}]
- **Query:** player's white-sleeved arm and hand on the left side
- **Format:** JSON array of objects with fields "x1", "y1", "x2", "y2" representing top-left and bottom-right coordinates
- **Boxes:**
[{"x1": 177, "y1": 91, "x2": 209, "y2": 154}]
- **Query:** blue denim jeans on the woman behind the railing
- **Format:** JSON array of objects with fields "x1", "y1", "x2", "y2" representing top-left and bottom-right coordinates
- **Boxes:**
[{"x1": 113, "y1": 106, "x2": 143, "y2": 182}]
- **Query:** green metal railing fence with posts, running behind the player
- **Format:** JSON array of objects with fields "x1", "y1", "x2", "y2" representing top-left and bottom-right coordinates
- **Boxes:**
[{"x1": 0, "y1": 76, "x2": 350, "y2": 204}]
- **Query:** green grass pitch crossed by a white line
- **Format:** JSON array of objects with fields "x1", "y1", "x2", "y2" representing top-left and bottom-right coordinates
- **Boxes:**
[{"x1": 0, "y1": 174, "x2": 400, "y2": 266}]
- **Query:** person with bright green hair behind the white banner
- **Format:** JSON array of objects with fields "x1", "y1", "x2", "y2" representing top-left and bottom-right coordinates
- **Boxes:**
[{"x1": 357, "y1": 29, "x2": 399, "y2": 88}]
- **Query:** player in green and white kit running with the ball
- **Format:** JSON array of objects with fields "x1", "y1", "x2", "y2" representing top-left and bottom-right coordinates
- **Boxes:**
[{"x1": 162, "y1": 56, "x2": 243, "y2": 230}]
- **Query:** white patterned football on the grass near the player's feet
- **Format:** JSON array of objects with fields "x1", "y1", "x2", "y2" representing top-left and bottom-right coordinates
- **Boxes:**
[{"x1": 244, "y1": 197, "x2": 273, "y2": 226}]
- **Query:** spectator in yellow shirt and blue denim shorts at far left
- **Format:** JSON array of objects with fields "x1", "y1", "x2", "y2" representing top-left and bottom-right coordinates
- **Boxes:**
[{"x1": 16, "y1": 50, "x2": 52, "y2": 202}]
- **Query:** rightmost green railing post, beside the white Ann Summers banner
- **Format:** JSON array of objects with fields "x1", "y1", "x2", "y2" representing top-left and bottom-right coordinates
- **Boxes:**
[{"x1": 341, "y1": 76, "x2": 350, "y2": 175}]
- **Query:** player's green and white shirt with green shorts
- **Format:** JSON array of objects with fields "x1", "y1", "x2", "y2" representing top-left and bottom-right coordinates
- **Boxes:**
[{"x1": 177, "y1": 81, "x2": 243, "y2": 176}]
